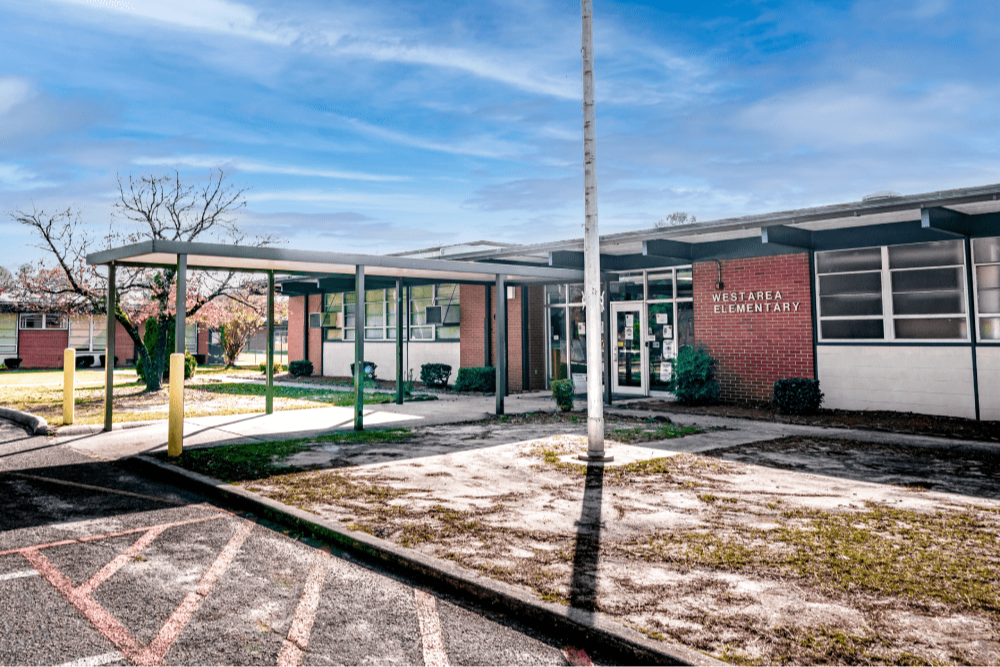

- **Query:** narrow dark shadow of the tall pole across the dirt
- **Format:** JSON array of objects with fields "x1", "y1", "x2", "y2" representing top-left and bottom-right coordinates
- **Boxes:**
[{"x1": 569, "y1": 463, "x2": 604, "y2": 613}]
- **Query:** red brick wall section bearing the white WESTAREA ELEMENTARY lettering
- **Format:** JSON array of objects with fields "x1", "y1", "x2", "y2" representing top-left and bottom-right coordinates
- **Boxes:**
[{"x1": 694, "y1": 253, "x2": 813, "y2": 401}]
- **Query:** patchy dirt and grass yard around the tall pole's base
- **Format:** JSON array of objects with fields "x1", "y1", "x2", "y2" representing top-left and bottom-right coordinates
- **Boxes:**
[{"x1": 180, "y1": 415, "x2": 1000, "y2": 666}]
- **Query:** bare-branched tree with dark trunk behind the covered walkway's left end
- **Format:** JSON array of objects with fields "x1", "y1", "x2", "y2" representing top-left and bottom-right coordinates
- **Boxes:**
[{"x1": 10, "y1": 170, "x2": 274, "y2": 391}]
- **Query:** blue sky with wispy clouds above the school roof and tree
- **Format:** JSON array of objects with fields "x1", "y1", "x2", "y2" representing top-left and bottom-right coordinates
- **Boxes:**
[{"x1": 0, "y1": 0, "x2": 1000, "y2": 269}]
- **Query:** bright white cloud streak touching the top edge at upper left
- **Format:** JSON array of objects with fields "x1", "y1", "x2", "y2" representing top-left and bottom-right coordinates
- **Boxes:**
[{"x1": 51, "y1": 0, "x2": 297, "y2": 44}]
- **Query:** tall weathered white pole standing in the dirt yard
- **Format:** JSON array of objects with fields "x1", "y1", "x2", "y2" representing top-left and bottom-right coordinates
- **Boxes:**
[{"x1": 580, "y1": 0, "x2": 611, "y2": 461}]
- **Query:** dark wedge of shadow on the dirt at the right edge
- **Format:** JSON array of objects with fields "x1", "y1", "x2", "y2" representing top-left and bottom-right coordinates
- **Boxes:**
[{"x1": 703, "y1": 436, "x2": 1000, "y2": 500}]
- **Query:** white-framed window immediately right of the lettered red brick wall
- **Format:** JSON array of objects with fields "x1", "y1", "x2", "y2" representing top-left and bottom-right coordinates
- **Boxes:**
[{"x1": 816, "y1": 241, "x2": 969, "y2": 340}]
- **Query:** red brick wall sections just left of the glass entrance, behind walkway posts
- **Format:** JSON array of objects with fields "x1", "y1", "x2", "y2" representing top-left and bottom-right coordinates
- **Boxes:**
[{"x1": 459, "y1": 285, "x2": 545, "y2": 393}]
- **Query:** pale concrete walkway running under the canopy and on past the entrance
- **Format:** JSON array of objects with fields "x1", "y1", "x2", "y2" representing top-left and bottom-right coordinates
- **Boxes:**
[{"x1": 55, "y1": 392, "x2": 996, "y2": 460}]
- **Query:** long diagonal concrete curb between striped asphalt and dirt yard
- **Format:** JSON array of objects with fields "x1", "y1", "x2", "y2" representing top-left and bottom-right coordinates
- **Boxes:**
[{"x1": 123, "y1": 455, "x2": 728, "y2": 667}]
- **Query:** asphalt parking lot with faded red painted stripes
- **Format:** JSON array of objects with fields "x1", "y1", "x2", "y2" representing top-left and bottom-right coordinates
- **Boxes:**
[{"x1": 0, "y1": 421, "x2": 612, "y2": 667}]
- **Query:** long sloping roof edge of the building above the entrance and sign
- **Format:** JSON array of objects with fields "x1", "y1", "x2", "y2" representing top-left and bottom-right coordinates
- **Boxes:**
[{"x1": 442, "y1": 184, "x2": 1000, "y2": 260}]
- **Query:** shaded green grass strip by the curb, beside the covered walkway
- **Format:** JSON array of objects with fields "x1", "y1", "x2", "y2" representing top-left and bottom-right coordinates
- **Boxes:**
[{"x1": 157, "y1": 428, "x2": 411, "y2": 483}]
